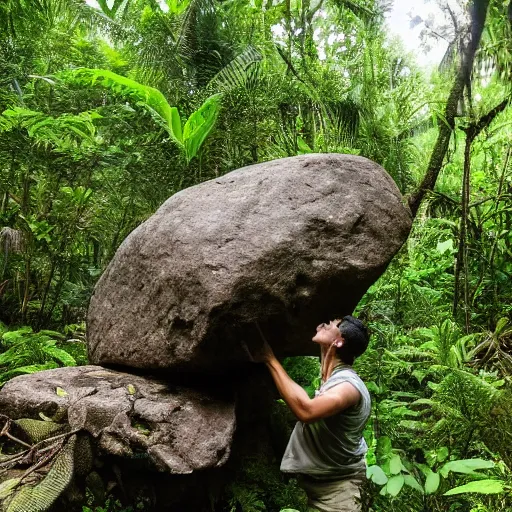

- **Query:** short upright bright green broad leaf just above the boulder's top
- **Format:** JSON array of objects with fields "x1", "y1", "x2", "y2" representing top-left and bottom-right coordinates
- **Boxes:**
[{"x1": 183, "y1": 94, "x2": 221, "y2": 162}]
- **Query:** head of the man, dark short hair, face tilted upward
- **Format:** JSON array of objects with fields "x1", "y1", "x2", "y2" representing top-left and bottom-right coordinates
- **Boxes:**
[{"x1": 313, "y1": 316, "x2": 369, "y2": 364}]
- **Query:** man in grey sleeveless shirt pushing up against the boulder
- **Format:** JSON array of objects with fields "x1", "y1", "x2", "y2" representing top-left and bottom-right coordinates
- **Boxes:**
[{"x1": 257, "y1": 316, "x2": 371, "y2": 512}]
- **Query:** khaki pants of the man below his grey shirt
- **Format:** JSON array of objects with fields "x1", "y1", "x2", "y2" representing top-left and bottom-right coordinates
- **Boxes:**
[{"x1": 298, "y1": 475, "x2": 365, "y2": 512}]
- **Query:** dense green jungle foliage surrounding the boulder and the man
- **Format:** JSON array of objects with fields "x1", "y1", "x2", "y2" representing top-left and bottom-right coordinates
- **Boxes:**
[{"x1": 0, "y1": 0, "x2": 512, "y2": 512}]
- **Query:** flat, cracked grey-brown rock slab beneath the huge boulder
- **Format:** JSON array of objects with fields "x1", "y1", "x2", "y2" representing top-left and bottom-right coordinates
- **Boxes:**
[{"x1": 0, "y1": 366, "x2": 235, "y2": 474}]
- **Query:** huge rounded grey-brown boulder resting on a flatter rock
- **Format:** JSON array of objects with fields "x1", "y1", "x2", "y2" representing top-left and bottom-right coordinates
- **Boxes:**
[{"x1": 88, "y1": 154, "x2": 411, "y2": 372}]
